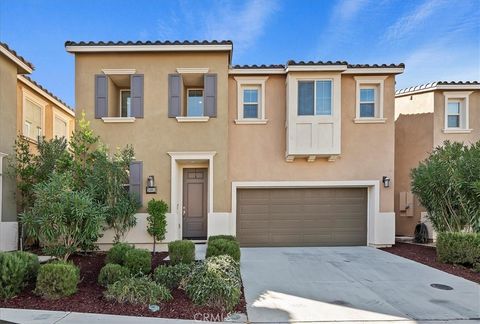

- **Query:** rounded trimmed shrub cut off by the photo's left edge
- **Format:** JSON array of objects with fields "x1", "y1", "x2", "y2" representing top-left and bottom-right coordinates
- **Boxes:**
[{"x1": 0, "y1": 252, "x2": 28, "y2": 299}]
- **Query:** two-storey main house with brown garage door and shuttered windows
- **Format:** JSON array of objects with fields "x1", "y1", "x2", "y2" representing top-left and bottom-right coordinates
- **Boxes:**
[{"x1": 65, "y1": 41, "x2": 404, "y2": 248}]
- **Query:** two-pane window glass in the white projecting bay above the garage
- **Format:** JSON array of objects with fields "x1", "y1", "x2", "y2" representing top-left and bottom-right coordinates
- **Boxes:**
[{"x1": 298, "y1": 80, "x2": 332, "y2": 116}]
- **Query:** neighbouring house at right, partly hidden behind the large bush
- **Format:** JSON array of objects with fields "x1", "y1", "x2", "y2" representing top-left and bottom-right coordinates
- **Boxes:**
[{"x1": 394, "y1": 81, "x2": 480, "y2": 239}]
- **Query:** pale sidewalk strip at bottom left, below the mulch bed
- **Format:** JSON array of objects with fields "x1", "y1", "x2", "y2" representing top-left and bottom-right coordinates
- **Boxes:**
[{"x1": 0, "y1": 308, "x2": 240, "y2": 324}]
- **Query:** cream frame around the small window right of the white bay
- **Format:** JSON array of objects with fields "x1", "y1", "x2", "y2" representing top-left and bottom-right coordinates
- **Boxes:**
[{"x1": 353, "y1": 75, "x2": 388, "y2": 124}]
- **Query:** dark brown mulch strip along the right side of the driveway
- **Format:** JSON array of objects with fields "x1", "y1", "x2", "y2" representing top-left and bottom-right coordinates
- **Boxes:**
[{"x1": 382, "y1": 242, "x2": 480, "y2": 283}]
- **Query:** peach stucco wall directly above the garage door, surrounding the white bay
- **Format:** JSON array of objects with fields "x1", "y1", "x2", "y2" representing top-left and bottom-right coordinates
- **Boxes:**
[{"x1": 228, "y1": 75, "x2": 395, "y2": 212}]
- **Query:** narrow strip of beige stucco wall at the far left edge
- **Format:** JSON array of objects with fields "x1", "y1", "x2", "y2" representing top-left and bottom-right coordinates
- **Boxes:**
[{"x1": 0, "y1": 54, "x2": 17, "y2": 221}]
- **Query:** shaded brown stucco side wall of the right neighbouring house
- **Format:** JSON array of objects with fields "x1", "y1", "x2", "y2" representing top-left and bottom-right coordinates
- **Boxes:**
[{"x1": 395, "y1": 112, "x2": 433, "y2": 236}]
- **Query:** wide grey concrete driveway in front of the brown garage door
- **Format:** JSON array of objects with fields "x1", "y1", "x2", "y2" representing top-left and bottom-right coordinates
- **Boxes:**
[{"x1": 241, "y1": 247, "x2": 480, "y2": 323}]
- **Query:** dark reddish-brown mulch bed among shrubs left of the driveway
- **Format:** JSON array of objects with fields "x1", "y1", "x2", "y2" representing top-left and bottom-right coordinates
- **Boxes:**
[{"x1": 0, "y1": 252, "x2": 246, "y2": 319}]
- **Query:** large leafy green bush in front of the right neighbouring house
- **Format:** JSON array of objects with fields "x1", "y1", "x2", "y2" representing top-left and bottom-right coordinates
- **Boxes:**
[{"x1": 411, "y1": 141, "x2": 480, "y2": 232}]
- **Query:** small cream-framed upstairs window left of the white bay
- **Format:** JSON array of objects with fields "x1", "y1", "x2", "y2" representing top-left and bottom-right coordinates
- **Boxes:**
[{"x1": 235, "y1": 76, "x2": 268, "y2": 125}]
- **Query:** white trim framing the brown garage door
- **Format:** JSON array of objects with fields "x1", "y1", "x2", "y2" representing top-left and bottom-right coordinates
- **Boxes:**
[{"x1": 231, "y1": 180, "x2": 380, "y2": 245}]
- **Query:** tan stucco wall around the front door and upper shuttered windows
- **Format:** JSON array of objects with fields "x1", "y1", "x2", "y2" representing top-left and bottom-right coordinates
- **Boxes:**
[{"x1": 75, "y1": 52, "x2": 230, "y2": 212}]
